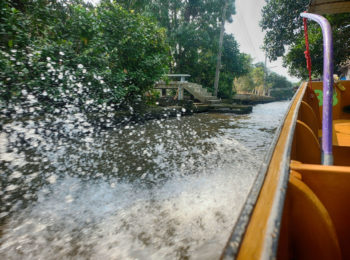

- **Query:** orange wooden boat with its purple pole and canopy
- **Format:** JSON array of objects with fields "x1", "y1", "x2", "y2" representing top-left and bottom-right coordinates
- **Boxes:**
[{"x1": 221, "y1": 0, "x2": 350, "y2": 260}]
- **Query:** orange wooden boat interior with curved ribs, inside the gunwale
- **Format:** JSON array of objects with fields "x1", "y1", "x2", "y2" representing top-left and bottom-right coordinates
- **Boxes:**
[{"x1": 277, "y1": 81, "x2": 350, "y2": 259}]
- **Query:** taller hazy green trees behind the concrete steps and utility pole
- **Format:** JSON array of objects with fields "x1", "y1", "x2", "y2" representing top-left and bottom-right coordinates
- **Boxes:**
[{"x1": 118, "y1": 0, "x2": 246, "y2": 97}]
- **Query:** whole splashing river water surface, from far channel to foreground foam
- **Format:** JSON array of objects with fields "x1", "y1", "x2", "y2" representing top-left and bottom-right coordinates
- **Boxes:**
[{"x1": 0, "y1": 102, "x2": 289, "y2": 259}]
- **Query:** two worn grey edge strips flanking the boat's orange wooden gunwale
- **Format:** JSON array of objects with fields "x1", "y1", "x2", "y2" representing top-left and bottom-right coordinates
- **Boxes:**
[{"x1": 220, "y1": 82, "x2": 308, "y2": 259}]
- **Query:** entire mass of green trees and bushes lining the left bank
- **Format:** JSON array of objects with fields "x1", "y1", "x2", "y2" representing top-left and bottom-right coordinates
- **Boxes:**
[{"x1": 0, "y1": 0, "x2": 291, "y2": 117}]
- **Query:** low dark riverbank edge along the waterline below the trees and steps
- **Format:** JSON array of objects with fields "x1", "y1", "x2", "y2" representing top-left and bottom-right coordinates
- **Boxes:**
[{"x1": 0, "y1": 98, "x2": 253, "y2": 130}]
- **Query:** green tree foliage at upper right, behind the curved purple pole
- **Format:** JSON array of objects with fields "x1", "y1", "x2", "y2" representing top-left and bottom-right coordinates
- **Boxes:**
[{"x1": 260, "y1": 0, "x2": 350, "y2": 78}]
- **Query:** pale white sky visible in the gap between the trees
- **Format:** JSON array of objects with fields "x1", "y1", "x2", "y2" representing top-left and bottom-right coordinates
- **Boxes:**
[{"x1": 225, "y1": 0, "x2": 299, "y2": 82}]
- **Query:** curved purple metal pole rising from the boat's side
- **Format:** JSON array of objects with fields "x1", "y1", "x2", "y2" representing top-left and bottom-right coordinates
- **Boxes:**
[{"x1": 300, "y1": 13, "x2": 333, "y2": 165}]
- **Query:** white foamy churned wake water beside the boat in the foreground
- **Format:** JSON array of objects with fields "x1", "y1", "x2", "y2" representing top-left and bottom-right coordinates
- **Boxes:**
[{"x1": 0, "y1": 164, "x2": 254, "y2": 259}]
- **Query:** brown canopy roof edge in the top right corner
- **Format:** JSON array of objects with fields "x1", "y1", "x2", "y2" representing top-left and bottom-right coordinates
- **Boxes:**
[{"x1": 308, "y1": 0, "x2": 350, "y2": 14}]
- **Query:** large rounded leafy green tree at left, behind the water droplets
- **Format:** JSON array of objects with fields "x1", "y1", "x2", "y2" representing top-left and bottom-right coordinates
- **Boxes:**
[{"x1": 0, "y1": 0, "x2": 169, "y2": 108}]
